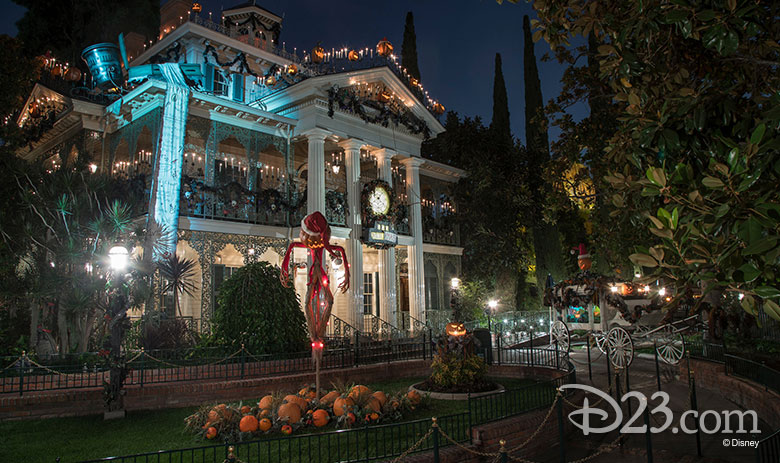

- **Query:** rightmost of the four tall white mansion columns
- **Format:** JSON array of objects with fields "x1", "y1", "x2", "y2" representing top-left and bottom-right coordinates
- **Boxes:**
[{"x1": 401, "y1": 158, "x2": 425, "y2": 322}]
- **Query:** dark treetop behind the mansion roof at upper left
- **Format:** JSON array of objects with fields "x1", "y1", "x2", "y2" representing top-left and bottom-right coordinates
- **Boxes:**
[{"x1": 13, "y1": 0, "x2": 160, "y2": 64}]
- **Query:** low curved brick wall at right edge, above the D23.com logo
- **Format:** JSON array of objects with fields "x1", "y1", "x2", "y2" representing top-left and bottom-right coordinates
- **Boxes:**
[{"x1": 680, "y1": 359, "x2": 780, "y2": 429}]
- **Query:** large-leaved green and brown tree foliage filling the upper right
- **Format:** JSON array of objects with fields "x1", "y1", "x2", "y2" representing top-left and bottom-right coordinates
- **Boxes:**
[{"x1": 534, "y1": 0, "x2": 780, "y2": 319}]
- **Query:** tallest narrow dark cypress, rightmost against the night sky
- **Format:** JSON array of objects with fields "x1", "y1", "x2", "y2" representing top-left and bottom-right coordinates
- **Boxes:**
[{"x1": 523, "y1": 16, "x2": 564, "y2": 288}]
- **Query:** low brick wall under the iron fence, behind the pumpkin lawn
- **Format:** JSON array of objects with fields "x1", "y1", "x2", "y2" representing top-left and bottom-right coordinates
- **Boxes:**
[{"x1": 0, "y1": 360, "x2": 431, "y2": 421}]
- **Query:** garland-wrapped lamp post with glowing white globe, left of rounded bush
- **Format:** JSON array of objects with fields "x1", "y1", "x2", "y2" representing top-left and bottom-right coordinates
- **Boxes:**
[{"x1": 103, "y1": 245, "x2": 129, "y2": 419}]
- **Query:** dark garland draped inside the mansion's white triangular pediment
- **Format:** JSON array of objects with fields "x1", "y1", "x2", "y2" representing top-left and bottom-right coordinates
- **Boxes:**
[{"x1": 328, "y1": 85, "x2": 431, "y2": 140}]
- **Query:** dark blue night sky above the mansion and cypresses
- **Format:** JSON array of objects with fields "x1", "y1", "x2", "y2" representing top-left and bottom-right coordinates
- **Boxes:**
[{"x1": 0, "y1": 0, "x2": 587, "y2": 141}]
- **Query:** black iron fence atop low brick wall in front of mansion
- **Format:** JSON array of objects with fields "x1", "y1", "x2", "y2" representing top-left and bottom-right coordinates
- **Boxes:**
[{"x1": 0, "y1": 336, "x2": 433, "y2": 395}]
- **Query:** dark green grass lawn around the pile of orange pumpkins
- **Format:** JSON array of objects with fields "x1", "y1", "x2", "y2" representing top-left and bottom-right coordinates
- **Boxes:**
[{"x1": 0, "y1": 378, "x2": 544, "y2": 463}]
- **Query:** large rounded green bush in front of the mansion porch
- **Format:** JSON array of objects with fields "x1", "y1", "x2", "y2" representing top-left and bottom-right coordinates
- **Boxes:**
[{"x1": 213, "y1": 262, "x2": 307, "y2": 355}]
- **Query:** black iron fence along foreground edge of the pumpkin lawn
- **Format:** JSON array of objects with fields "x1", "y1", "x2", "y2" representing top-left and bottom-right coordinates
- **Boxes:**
[{"x1": 74, "y1": 349, "x2": 576, "y2": 463}]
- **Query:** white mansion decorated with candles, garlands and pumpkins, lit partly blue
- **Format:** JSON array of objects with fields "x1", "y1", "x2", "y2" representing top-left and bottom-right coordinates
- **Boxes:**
[{"x1": 19, "y1": 0, "x2": 463, "y2": 338}]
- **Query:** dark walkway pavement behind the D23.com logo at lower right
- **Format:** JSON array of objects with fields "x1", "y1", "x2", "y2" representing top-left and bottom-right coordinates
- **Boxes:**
[{"x1": 515, "y1": 351, "x2": 780, "y2": 463}]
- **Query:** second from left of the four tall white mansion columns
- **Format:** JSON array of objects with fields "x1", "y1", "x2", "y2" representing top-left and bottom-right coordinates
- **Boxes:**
[{"x1": 339, "y1": 139, "x2": 363, "y2": 329}]
